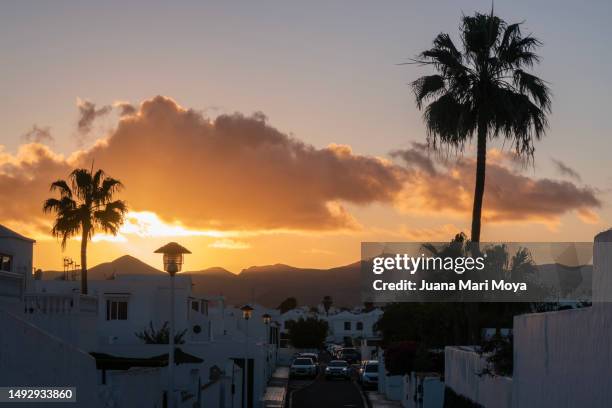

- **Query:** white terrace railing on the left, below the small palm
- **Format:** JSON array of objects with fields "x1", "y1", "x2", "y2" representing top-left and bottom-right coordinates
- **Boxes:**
[{"x1": 24, "y1": 293, "x2": 98, "y2": 315}]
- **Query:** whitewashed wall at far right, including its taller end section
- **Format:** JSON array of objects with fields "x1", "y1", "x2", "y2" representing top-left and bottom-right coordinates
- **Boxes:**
[{"x1": 513, "y1": 231, "x2": 612, "y2": 408}]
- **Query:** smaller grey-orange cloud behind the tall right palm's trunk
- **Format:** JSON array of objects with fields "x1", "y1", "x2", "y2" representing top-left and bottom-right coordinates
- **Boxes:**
[{"x1": 396, "y1": 146, "x2": 601, "y2": 223}]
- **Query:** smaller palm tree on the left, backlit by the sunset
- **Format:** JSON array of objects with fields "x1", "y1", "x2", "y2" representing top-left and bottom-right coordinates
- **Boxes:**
[{"x1": 43, "y1": 168, "x2": 127, "y2": 294}]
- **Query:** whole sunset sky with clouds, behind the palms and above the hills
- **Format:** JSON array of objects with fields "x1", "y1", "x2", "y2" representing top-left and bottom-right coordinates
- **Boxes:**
[{"x1": 0, "y1": 1, "x2": 612, "y2": 272}]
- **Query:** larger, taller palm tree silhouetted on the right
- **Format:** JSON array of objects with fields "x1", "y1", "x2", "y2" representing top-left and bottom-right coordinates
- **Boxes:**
[{"x1": 412, "y1": 11, "x2": 551, "y2": 243}]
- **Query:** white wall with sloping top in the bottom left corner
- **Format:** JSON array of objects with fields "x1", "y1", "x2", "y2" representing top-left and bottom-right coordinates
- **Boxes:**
[{"x1": 0, "y1": 310, "x2": 100, "y2": 408}]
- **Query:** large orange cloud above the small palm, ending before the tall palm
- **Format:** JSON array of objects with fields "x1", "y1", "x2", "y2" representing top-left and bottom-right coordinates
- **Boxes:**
[{"x1": 0, "y1": 96, "x2": 404, "y2": 231}]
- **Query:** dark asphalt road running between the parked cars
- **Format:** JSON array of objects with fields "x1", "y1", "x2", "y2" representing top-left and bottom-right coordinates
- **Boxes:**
[{"x1": 287, "y1": 352, "x2": 367, "y2": 408}]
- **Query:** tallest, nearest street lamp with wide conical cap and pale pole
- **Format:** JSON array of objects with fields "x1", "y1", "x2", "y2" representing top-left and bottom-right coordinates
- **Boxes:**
[{"x1": 154, "y1": 242, "x2": 191, "y2": 408}]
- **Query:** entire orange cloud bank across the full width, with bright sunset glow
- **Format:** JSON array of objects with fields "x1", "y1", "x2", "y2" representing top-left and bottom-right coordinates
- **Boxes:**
[{"x1": 0, "y1": 96, "x2": 601, "y2": 241}]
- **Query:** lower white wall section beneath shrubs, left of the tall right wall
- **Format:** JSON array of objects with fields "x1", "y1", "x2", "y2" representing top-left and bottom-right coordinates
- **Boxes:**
[{"x1": 444, "y1": 347, "x2": 513, "y2": 408}]
